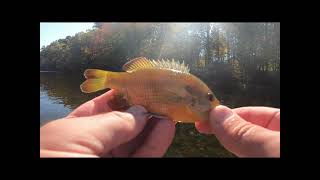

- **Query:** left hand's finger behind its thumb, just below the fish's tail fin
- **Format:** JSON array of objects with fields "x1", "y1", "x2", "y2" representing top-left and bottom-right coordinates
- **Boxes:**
[{"x1": 67, "y1": 89, "x2": 116, "y2": 118}]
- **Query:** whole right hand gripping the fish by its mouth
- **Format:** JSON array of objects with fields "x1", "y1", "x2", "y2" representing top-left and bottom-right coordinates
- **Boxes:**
[{"x1": 195, "y1": 106, "x2": 280, "y2": 157}]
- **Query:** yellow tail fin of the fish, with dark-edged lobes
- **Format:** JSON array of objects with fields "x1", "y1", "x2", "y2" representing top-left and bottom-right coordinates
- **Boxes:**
[{"x1": 80, "y1": 69, "x2": 108, "y2": 93}]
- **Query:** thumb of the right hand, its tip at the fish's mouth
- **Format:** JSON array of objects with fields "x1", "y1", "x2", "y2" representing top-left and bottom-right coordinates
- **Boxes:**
[{"x1": 210, "y1": 106, "x2": 280, "y2": 157}]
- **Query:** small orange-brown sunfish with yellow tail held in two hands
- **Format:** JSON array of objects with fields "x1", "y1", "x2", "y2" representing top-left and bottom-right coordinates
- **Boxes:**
[{"x1": 80, "y1": 57, "x2": 220, "y2": 123}]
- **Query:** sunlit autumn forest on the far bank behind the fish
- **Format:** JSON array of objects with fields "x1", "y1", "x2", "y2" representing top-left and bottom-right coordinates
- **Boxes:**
[{"x1": 40, "y1": 23, "x2": 280, "y2": 107}]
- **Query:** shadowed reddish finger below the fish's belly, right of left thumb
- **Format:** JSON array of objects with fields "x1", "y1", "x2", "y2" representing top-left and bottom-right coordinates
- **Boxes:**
[{"x1": 132, "y1": 119, "x2": 175, "y2": 157}]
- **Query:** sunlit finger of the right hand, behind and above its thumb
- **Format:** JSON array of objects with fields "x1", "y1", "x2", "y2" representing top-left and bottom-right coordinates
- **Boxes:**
[{"x1": 233, "y1": 107, "x2": 280, "y2": 131}]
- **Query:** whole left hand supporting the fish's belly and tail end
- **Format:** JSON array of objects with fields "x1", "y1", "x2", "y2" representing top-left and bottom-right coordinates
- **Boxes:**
[{"x1": 40, "y1": 90, "x2": 175, "y2": 157}]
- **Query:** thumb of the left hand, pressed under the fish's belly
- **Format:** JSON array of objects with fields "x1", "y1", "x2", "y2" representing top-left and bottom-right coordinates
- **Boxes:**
[{"x1": 64, "y1": 106, "x2": 147, "y2": 156}]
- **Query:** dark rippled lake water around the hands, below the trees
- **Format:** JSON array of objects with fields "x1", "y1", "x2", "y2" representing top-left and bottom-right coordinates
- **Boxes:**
[{"x1": 40, "y1": 72, "x2": 280, "y2": 157}]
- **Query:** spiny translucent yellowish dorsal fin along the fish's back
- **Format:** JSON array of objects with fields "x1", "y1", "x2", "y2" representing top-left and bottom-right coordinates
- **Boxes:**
[{"x1": 122, "y1": 57, "x2": 189, "y2": 73}]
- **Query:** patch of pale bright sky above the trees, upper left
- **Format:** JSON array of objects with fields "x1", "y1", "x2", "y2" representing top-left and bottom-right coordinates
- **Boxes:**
[{"x1": 40, "y1": 23, "x2": 93, "y2": 49}]
